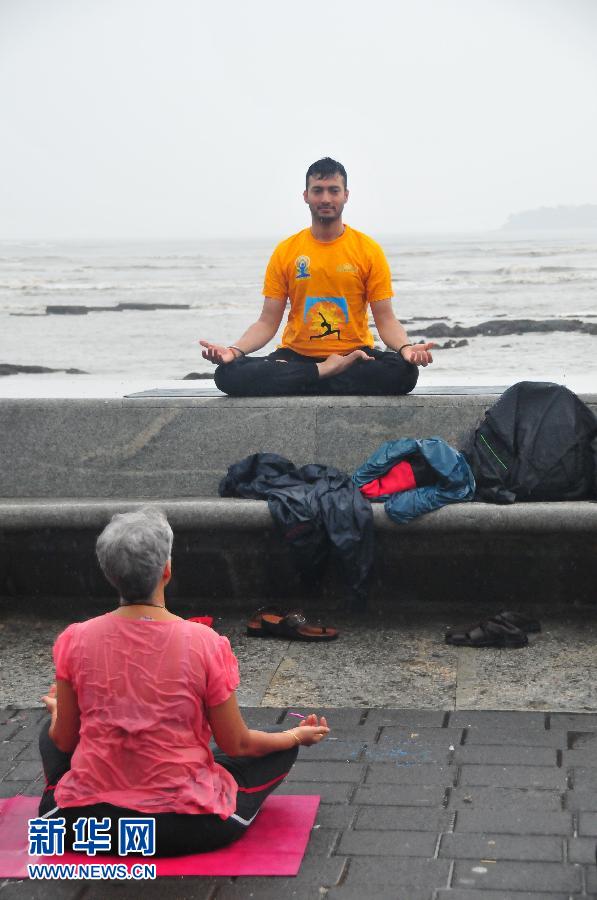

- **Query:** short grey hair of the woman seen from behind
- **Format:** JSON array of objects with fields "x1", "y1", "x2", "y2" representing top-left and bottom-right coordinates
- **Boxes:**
[{"x1": 95, "y1": 506, "x2": 173, "y2": 602}]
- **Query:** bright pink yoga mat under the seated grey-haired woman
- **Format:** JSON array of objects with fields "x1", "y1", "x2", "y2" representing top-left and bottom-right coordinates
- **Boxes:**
[{"x1": 0, "y1": 794, "x2": 320, "y2": 878}]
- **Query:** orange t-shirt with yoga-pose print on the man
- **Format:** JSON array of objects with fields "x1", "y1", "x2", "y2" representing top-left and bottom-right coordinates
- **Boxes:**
[{"x1": 263, "y1": 225, "x2": 394, "y2": 356}]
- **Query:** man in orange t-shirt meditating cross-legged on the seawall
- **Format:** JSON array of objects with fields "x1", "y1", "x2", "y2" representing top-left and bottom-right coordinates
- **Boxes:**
[{"x1": 199, "y1": 157, "x2": 434, "y2": 397}]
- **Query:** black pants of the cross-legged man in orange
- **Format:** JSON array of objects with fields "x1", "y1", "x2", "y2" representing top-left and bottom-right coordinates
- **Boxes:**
[{"x1": 214, "y1": 347, "x2": 419, "y2": 397}]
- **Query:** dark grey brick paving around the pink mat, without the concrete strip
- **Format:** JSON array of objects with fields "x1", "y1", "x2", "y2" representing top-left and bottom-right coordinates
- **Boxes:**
[{"x1": 0, "y1": 708, "x2": 597, "y2": 900}]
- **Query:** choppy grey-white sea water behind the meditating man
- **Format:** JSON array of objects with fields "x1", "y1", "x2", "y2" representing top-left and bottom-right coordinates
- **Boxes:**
[{"x1": 0, "y1": 231, "x2": 597, "y2": 392}]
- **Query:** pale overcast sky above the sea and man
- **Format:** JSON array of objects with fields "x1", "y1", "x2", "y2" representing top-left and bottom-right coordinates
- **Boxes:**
[{"x1": 0, "y1": 0, "x2": 597, "y2": 239}]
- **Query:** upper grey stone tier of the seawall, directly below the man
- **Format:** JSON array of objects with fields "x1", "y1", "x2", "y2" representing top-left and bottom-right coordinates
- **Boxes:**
[{"x1": 0, "y1": 395, "x2": 597, "y2": 498}]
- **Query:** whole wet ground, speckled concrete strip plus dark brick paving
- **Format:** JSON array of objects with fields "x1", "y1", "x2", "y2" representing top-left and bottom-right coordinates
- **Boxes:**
[{"x1": 0, "y1": 618, "x2": 597, "y2": 900}]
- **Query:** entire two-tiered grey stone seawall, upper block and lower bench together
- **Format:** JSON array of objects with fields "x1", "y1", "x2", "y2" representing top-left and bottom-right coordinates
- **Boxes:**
[{"x1": 0, "y1": 395, "x2": 597, "y2": 616}]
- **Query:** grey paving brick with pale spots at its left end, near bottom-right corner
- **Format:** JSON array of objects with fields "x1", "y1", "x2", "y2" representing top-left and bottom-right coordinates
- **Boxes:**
[{"x1": 452, "y1": 860, "x2": 582, "y2": 900}]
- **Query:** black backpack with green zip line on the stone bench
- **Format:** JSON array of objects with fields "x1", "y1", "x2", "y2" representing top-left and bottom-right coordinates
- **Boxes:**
[{"x1": 464, "y1": 381, "x2": 597, "y2": 503}]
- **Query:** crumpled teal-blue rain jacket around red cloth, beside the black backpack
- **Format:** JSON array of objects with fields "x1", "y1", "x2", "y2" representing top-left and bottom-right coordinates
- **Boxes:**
[{"x1": 352, "y1": 437, "x2": 475, "y2": 522}]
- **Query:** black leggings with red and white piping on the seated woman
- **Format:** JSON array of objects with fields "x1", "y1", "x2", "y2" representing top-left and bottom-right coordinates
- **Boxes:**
[{"x1": 39, "y1": 721, "x2": 298, "y2": 856}]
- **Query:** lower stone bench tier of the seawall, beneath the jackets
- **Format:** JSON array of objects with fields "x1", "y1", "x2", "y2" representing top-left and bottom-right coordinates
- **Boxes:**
[{"x1": 0, "y1": 499, "x2": 597, "y2": 616}]
